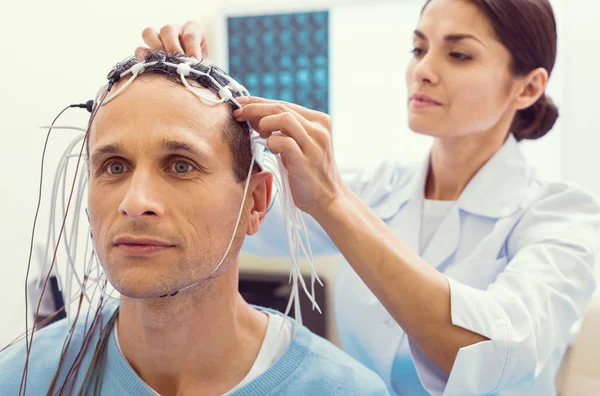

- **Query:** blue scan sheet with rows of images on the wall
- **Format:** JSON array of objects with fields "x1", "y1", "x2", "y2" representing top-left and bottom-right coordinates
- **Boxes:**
[{"x1": 227, "y1": 11, "x2": 329, "y2": 113}]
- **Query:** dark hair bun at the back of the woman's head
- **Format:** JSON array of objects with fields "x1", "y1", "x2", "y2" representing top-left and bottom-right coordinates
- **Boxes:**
[{"x1": 511, "y1": 94, "x2": 558, "y2": 141}]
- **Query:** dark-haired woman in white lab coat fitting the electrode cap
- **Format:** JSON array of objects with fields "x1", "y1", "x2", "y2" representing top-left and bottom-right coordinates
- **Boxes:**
[{"x1": 143, "y1": 0, "x2": 600, "y2": 395}]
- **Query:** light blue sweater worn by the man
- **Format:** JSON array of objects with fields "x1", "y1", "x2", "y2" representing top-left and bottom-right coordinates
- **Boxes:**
[{"x1": 0, "y1": 304, "x2": 389, "y2": 396}]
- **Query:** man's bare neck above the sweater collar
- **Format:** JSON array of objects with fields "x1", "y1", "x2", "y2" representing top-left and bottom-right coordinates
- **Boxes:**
[{"x1": 117, "y1": 268, "x2": 268, "y2": 395}]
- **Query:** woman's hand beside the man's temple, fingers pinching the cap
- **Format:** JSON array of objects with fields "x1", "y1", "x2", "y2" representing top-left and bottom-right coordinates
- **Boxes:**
[{"x1": 234, "y1": 97, "x2": 347, "y2": 217}]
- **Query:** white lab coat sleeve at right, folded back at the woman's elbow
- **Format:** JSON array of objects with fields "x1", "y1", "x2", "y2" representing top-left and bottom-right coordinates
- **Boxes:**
[{"x1": 411, "y1": 184, "x2": 600, "y2": 395}]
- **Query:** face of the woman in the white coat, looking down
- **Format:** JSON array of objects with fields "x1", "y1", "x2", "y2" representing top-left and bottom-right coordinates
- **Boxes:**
[{"x1": 406, "y1": 0, "x2": 516, "y2": 138}]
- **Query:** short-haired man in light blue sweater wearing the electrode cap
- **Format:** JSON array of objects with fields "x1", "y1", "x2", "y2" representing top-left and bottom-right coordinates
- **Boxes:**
[{"x1": 0, "y1": 52, "x2": 387, "y2": 395}]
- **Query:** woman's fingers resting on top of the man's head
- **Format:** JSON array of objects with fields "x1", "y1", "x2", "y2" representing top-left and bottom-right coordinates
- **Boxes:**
[{"x1": 135, "y1": 21, "x2": 210, "y2": 62}]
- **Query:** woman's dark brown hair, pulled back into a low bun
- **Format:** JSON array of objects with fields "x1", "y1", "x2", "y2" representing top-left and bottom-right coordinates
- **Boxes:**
[{"x1": 423, "y1": 0, "x2": 558, "y2": 141}]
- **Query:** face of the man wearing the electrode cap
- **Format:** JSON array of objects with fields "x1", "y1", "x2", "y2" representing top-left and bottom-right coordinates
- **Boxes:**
[{"x1": 88, "y1": 76, "x2": 255, "y2": 298}]
